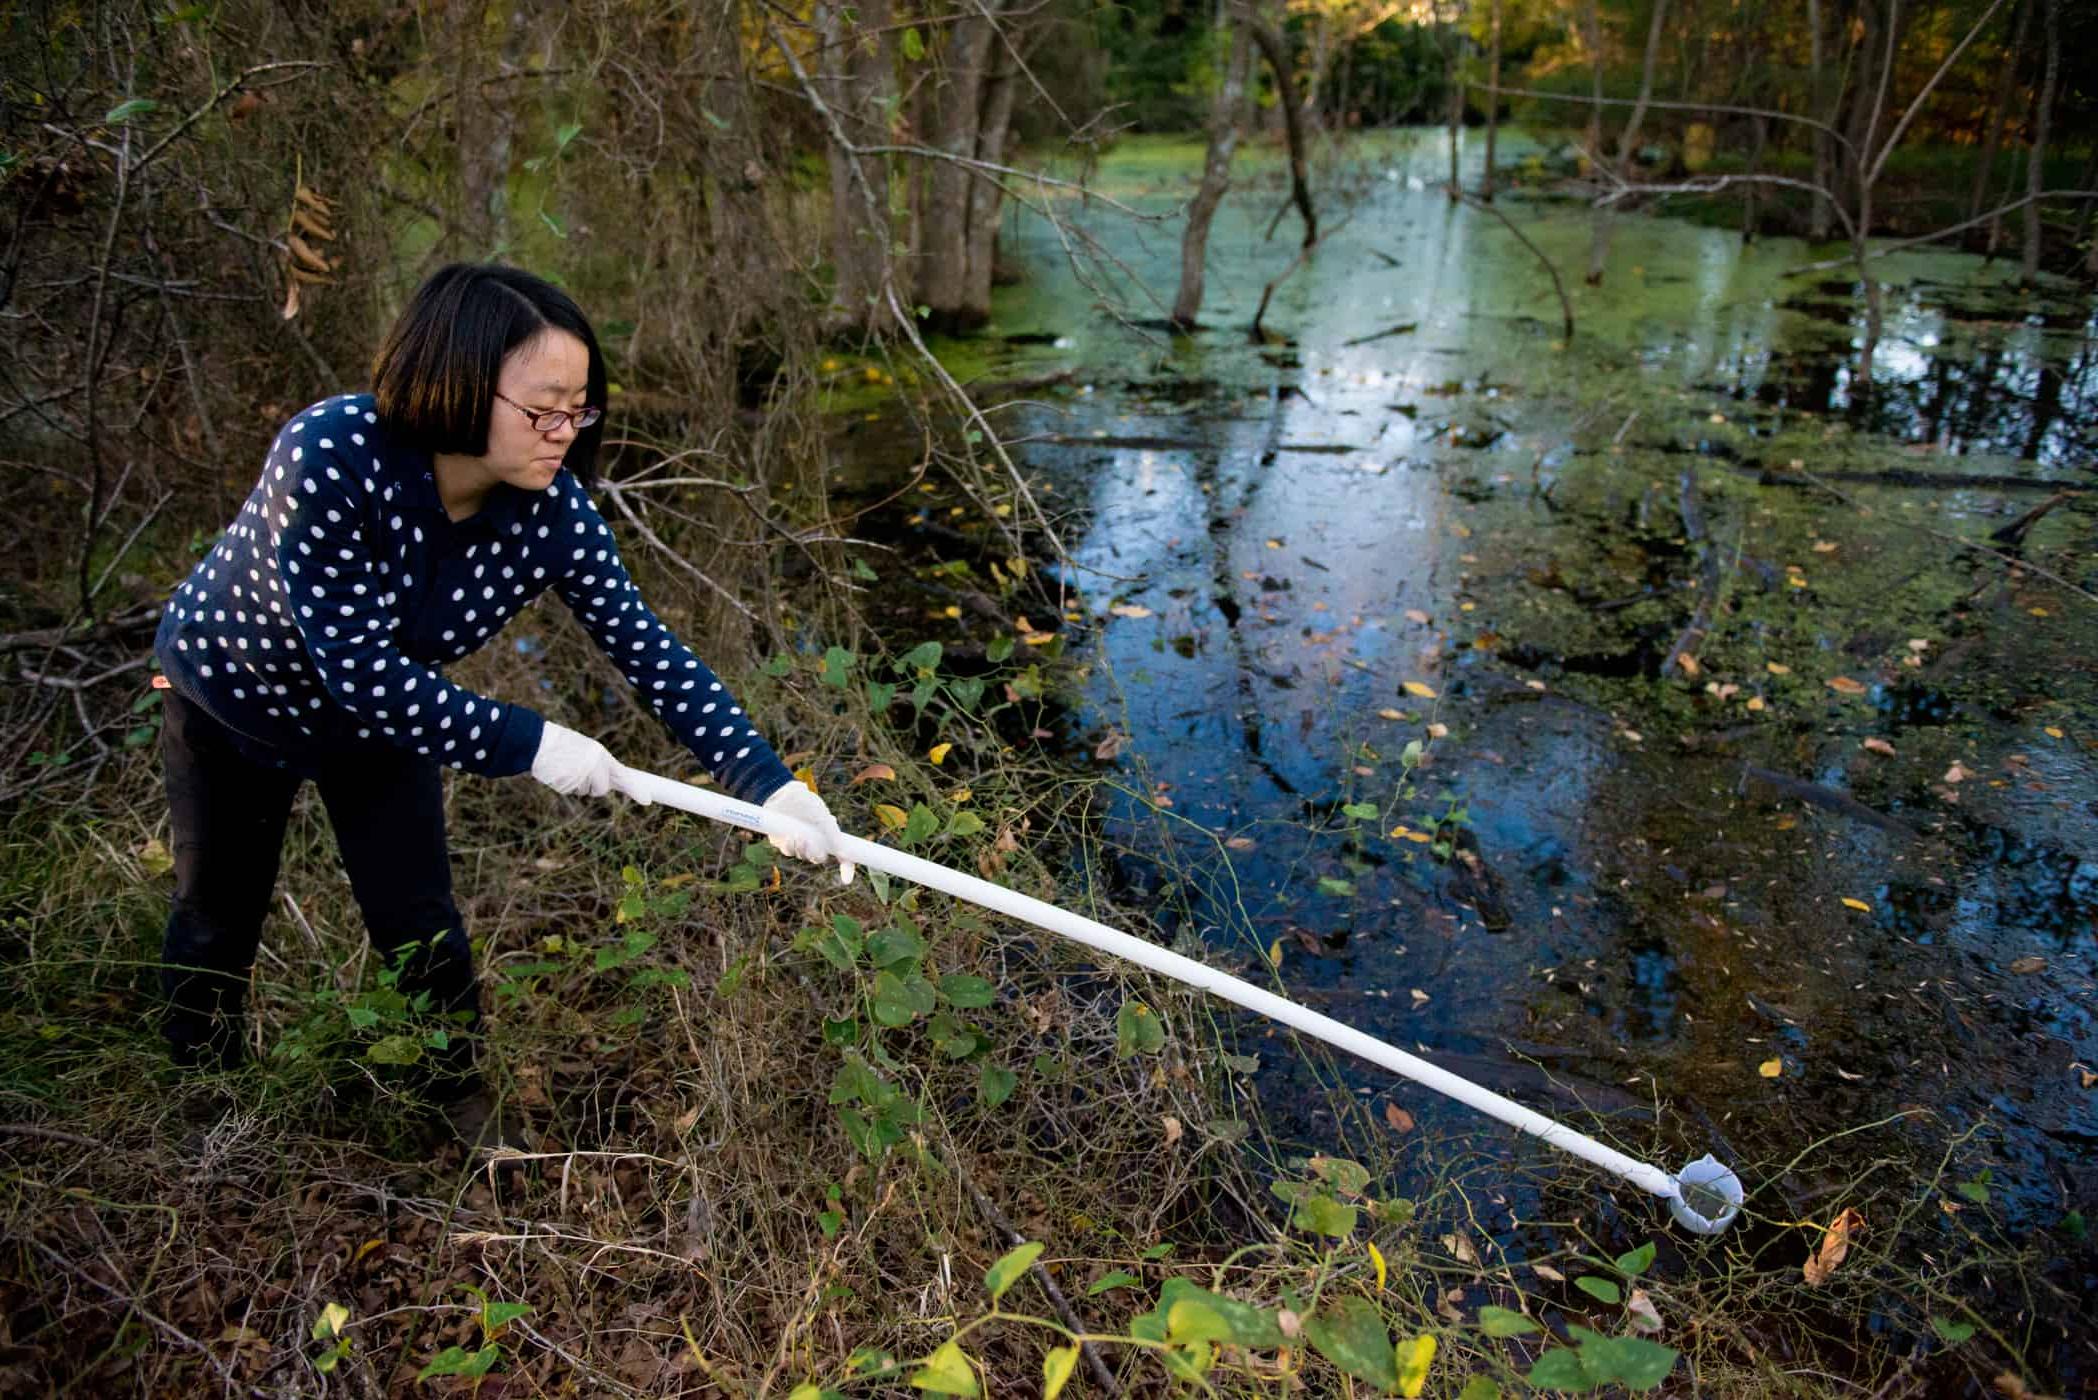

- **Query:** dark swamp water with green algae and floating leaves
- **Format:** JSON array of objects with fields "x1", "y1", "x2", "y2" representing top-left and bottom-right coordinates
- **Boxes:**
[{"x1": 826, "y1": 132, "x2": 2098, "y2": 1375}]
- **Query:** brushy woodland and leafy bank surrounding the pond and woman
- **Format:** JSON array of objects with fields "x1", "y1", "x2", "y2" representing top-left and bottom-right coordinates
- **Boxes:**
[{"x1": 0, "y1": 0, "x2": 2098, "y2": 1398}]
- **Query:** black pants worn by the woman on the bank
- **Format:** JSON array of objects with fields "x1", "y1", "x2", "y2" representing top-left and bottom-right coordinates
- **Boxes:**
[{"x1": 162, "y1": 691, "x2": 480, "y2": 1094}]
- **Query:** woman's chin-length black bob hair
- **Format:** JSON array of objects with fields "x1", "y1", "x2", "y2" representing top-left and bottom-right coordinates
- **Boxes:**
[{"x1": 371, "y1": 262, "x2": 604, "y2": 487}]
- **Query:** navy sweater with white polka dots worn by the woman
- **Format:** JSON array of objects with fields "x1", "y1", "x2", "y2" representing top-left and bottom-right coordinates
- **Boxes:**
[{"x1": 155, "y1": 395, "x2": 789, "y2": 802}]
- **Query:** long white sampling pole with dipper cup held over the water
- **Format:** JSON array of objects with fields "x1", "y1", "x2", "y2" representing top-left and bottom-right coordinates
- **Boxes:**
[{"x1": 617, "y1": 768, "x2": 1743, "y2": 1234}]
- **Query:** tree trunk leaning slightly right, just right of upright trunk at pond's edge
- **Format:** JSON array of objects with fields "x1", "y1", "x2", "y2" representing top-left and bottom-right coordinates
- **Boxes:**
[{"x1": 917, "y1": 4, "x2": 997, "y2": 332}]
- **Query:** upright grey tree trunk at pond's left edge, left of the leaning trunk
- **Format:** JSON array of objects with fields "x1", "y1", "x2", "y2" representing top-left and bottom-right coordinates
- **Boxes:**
[{"x1": 816, "y1": 0, "x2": 896, "y2": 334}]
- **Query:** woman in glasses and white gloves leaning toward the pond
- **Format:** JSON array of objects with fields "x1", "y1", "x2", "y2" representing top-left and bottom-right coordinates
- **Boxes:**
[{"x1": 155, "y1": 264, "x2": 852, "y2": 1138}]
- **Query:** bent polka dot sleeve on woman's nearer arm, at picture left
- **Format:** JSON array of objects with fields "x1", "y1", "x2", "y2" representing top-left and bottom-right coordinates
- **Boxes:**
[{"x1": 277, "y1": 453, "x2": 545, "y2": 777}]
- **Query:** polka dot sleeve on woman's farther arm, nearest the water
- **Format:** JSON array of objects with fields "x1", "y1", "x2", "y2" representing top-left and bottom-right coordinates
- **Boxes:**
[{"x1": 554, "y1": 485, "x2": 793, "y2": 802}]
